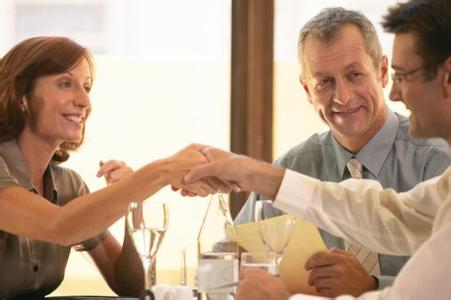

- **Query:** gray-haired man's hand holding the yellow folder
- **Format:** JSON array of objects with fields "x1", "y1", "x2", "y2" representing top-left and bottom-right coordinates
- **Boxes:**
[{"x1": 305, "y1": 248, "x2": 377, "y2": 297}]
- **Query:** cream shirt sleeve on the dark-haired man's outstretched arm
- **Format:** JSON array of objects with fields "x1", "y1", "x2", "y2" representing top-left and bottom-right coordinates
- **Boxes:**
[{"x1": 275, "y1": 170, "x2": 442, "y2": 255}]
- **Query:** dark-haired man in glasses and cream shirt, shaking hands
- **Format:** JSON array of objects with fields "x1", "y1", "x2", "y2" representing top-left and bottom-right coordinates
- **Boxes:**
[{"x1": 185, "y1": 0, "x2": 451, "y2": 300}]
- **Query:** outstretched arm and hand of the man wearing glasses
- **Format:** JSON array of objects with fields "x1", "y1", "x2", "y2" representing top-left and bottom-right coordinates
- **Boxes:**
[{"x1": 185, "y1": 147, "x2": 451, "y2": 255}]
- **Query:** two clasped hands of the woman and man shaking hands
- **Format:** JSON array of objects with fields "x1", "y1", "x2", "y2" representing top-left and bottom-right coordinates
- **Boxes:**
[{"x1": 164, "y1": 144, "x2": 284, "y2": 199}]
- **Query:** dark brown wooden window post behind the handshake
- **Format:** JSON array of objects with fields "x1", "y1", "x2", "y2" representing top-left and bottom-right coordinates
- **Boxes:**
[{"x1": 231, "y1": 0, "x2": 274, "y2": 215}]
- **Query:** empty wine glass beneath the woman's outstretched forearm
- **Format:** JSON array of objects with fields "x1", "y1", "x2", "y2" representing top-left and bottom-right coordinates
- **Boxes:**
[{"x1": 127, "y1": 200, "x2": 169, "y2": 300}]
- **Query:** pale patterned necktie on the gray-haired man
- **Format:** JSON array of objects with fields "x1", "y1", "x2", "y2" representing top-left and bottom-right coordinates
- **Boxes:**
[{"x1": 345, "y1": 158, "x2": 381, "y2": 275}]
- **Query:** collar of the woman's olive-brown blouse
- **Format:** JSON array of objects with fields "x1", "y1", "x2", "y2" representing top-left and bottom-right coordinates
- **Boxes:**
[{"x1": 0, "y1": 139, "x2": 57, "y2": 202}]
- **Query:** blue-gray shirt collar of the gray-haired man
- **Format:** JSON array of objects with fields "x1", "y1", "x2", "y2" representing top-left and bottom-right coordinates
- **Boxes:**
[{"x1": 332, "y1": 108, "x2": 399, "y2": 177}]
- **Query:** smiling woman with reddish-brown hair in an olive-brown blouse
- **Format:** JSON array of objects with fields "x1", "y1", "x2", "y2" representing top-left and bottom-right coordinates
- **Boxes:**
[{"x1": 0, "y1": 37, "x2": 212, "y2": 299}]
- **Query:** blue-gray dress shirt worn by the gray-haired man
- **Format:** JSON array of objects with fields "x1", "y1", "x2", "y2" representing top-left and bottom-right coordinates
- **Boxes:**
[{"x1": 235, "y1": 109, "x2": 451, "y2": 289}]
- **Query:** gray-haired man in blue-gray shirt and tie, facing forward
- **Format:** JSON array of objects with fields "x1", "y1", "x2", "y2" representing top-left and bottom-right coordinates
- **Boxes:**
[{"x1": 235, "y1": 7, "x2": 451, "y2": 297}]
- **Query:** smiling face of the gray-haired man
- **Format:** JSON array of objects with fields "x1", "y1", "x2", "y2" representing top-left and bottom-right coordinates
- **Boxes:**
[{"x1": 301, "y1": 25, "x2": 387, "y2": 150}]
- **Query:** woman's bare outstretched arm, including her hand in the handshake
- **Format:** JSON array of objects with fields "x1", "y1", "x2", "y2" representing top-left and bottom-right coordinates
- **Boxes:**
[{"x1": 0, "y1": 145, "x2": 206, "y2": 246}]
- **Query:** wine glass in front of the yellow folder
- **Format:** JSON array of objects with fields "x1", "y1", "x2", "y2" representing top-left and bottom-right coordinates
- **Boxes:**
[{"x1": 254, "y1": 200, "x2": 296, "y2": 276}]
